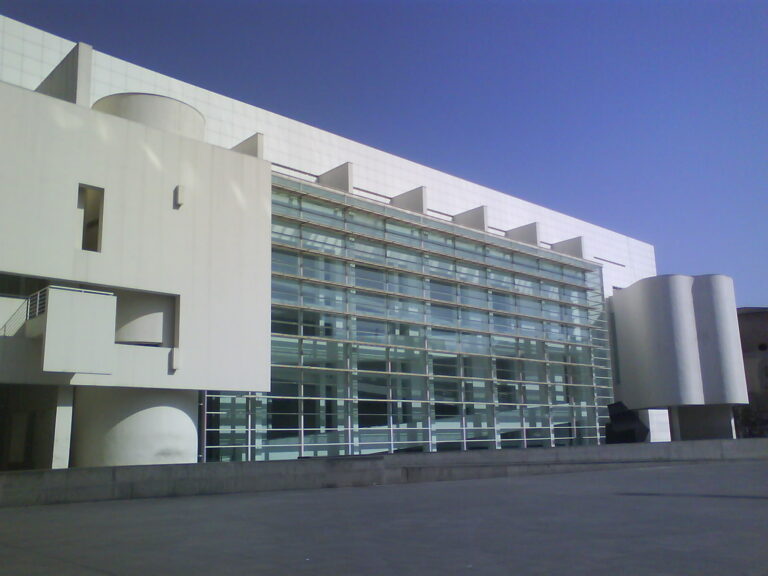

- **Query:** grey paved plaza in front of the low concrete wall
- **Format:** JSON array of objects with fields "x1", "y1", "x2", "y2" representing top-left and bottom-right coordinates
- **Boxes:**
[{"x1": 0, "y1": 460, "x2": 768, "y2": 576}]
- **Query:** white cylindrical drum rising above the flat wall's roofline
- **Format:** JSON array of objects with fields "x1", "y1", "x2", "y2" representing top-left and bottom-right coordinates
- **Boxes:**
[{"x1": 93, "y1": 92, "x2": 205, "y2": 140}]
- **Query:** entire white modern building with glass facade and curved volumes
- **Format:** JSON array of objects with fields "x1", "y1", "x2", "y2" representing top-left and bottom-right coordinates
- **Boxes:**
[{"x1": 0, "y1": 17, "x2": 746, "y2": 469}]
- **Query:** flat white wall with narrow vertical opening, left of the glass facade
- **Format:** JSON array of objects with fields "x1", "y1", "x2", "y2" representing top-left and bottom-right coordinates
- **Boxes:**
[{"x1": 0, "y1": 84, "x2": 271, "y2": 390}]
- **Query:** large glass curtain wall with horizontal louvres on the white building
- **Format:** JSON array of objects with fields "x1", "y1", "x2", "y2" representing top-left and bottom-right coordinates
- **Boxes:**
[{"x1": 205, "y1": 175, "x2": 612, "y2": 461}]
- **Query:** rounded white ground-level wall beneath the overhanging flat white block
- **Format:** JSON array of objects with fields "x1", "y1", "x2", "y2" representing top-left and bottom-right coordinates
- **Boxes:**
[{"x1": 72, "y1": 387, "x2": 198, "y2": 467}]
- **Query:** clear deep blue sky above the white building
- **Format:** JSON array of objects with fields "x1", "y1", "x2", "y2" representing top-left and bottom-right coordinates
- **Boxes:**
[{"x1": 0, "y1": 0, "x2": 768, "y2": 306}]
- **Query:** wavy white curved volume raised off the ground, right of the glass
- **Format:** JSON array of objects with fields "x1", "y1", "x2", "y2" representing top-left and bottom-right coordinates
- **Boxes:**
[{"x1": 611, "y1": 275, "x2": 747, "y2": 409}]
